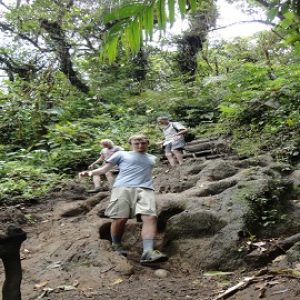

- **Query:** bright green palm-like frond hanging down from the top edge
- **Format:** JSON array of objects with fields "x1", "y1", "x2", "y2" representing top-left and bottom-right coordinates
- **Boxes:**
[{"x1": 102, "y1": 0, "x2": 197, "y2": 63}]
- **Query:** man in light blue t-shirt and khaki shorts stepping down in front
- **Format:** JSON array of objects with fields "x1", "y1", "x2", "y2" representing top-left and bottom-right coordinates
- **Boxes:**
[{"x1": 79, "y1": 134, "x2": 168, "y2": 264}]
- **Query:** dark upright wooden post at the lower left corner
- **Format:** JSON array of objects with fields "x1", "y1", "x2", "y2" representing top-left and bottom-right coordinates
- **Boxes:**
[{"x1": 0, "y1": 225, "x2": 26, "y2": 300}]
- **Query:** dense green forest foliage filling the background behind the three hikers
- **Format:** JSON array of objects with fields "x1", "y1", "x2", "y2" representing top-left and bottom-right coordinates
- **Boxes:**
[{"x1": 0, "y1": 0, "x2": 300, "y2": 206}]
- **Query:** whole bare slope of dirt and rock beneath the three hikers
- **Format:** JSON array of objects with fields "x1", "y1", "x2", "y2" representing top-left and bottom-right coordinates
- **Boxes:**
[{"x1": 0, "y1": 139, "x2": 300, "y2": 300}]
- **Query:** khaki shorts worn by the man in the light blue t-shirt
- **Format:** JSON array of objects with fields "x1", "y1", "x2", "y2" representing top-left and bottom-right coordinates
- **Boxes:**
[{"x1": 105, "y1": 187, "x2": 156, "y2": 219}]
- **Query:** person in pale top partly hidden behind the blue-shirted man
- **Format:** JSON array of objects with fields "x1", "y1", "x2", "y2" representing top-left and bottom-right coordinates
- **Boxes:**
[{"x1": 89, "y1": 139, "x2": 124, "y2": 193}]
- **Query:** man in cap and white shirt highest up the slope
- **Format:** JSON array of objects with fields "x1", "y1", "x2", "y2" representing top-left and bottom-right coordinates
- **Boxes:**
[{"x1": 157, "y1": 117, "x2": 188, "y2": 167}]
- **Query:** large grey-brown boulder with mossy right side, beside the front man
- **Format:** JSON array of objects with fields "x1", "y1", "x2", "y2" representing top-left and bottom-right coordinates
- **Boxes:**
[{"x1": 158, "y1": 156, "x2": 300, "y2": 270}]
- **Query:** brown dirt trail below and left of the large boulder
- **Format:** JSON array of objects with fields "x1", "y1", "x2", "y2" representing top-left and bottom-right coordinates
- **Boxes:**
[{"x1": 0, "y1": 141, "x2": 300, "y2": 300}]
